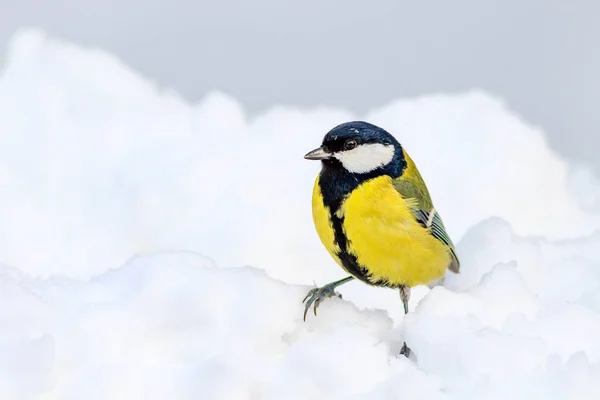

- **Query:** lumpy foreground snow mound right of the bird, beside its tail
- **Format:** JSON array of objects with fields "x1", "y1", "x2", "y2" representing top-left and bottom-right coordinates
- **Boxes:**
[{"x1": 404, "y1": 219, "x2": 600, "y2": 399}]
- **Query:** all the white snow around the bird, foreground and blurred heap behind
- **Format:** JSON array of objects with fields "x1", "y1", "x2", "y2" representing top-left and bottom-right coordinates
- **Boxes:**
[{"x1": 0, "y1": 29, "x2": 600, "y2": 399}]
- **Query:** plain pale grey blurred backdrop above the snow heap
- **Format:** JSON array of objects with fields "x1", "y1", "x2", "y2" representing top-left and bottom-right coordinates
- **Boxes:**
[{"x1": 0, "y1": 0, "x2": 600, "y2": 173}]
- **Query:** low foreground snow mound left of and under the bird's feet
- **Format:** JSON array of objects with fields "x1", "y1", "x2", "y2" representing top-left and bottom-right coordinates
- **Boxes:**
[{"x1": 0, "y1": 252, "x2": 434, "y2": 399}]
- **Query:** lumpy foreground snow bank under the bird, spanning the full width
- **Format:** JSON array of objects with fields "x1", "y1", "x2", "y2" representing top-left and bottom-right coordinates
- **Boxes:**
[{"x1": 0, "y1": 219, "x2": 600, "y2": 399}]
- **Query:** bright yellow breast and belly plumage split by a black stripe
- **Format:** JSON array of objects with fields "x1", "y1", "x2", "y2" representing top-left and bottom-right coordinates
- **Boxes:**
[{"x1": 313, "y1": 176, "x2": 450, "y2": 286}]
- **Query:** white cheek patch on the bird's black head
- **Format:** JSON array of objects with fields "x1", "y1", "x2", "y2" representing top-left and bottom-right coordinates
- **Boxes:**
[{"x1": 333, "y1": 143, "x2": 394, "y2": 174}]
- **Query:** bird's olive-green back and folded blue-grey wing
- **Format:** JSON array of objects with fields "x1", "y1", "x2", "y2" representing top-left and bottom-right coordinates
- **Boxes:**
[{"x1": 393, "y1": 148, "x2": 460, "y2": 273}]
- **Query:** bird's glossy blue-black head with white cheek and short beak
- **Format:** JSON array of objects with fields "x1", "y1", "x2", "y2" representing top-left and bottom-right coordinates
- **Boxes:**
[{"x1": 304, "y1": 121, "x2": 404, "y2": 176}]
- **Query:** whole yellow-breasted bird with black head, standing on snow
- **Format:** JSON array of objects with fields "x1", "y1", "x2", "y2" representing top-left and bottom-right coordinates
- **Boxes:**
[{"x1": 302, "y1": 121, "x2": 460, "y2": 357}]
